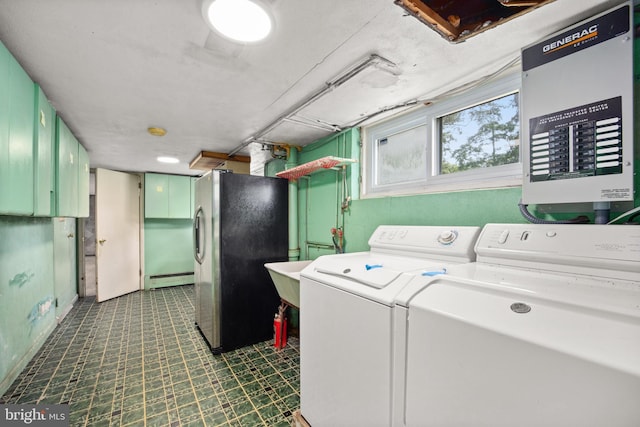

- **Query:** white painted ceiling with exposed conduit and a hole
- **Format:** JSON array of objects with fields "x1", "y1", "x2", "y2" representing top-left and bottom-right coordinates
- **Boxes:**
[{"x1": 0, "y1": 0, "x2": 620, "y2": 174}]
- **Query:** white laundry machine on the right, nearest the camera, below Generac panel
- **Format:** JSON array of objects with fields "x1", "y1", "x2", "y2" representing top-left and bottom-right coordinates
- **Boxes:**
[{"x1": 394, "y1": 224, "x2": 640, "y2": 427}]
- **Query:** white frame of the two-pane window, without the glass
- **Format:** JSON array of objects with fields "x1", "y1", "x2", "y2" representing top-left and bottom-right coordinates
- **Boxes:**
[{"x1": 361, "y1": 73, "x2": 522, "y2": 198}]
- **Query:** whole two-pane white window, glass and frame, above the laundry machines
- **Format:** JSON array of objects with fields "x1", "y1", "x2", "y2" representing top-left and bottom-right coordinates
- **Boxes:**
[{"x1": 363, "y1": 74, "x2": 522, "y2": 197}]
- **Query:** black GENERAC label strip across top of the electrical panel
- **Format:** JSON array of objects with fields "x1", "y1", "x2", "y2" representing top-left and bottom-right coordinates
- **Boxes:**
[{"x1": 522, "y1": 4, "x2": 631, "y2": 71}]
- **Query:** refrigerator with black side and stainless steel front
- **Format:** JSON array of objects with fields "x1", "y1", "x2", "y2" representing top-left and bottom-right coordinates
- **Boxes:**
[{"x1": 193, "y1": 170, "x2": 289, "y2": 354}]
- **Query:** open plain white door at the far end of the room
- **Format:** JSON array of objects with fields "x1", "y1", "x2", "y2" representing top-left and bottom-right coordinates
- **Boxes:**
[{"x1": 95, "y1": 169, "x2": 140, "y2": 302}]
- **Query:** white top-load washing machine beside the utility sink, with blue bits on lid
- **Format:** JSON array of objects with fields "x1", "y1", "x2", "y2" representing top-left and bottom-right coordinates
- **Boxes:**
[{"x1": 300, "y1": 226, "x2": 480, "y2": 427}]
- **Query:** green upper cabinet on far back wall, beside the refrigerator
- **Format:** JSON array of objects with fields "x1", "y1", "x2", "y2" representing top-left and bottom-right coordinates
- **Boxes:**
[{"x1": 144, "y1": 173, "x2": 192, "y2": 219}]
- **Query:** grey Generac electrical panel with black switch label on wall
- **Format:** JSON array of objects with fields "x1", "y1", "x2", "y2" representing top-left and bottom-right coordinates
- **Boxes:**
[{"x1": 521, "y1": 2, "x2": 634, "y2": 204}]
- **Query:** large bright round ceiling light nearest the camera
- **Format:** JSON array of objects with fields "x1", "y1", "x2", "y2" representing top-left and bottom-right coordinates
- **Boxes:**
[{"x1": 202, "y1": 0, "x2": 273, "y2": 43}]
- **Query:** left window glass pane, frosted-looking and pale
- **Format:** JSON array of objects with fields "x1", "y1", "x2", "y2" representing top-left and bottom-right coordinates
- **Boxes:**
[{"x1": 375, "y1": 125, "x2": 427, "y2": 185}]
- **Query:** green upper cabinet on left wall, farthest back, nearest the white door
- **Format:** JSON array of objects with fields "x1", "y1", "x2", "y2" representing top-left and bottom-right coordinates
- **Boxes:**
[{"x1": 56, "y1": 116, "x2": 89, "y2": 217}]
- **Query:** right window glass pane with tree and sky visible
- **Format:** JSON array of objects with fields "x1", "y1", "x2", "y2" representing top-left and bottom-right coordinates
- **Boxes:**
[{"x1": 438, "y1": 93, "x2": 520, "y2": 174}]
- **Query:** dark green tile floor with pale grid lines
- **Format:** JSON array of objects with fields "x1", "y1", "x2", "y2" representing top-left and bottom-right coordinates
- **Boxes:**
[{"x1": 0, "y1": 286, "x2": 300, "y2": 427}]
